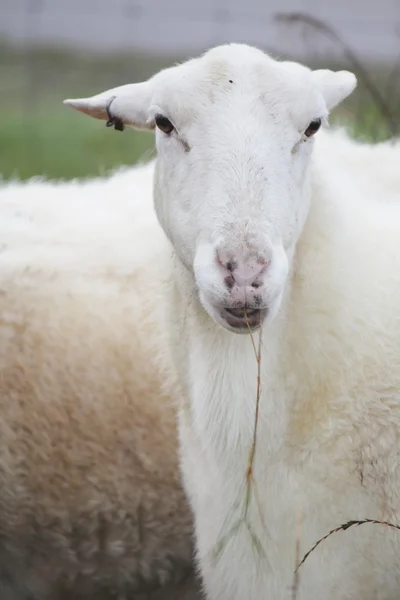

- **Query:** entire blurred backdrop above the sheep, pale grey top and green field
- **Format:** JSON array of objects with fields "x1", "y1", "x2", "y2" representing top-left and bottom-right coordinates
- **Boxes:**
[{"x1": 0, "y1": 0, "x2": 400, "y2": 179}]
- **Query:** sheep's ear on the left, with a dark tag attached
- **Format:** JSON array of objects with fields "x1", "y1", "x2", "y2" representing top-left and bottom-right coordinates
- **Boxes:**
[{"x1": 64, "y1": 80, "x2": 154, "y2": 131}]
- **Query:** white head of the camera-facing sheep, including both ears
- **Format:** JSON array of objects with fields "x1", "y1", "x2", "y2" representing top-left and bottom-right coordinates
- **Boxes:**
[{"x1": 63, "y1": 44, "x2": 356, "y2": 333}]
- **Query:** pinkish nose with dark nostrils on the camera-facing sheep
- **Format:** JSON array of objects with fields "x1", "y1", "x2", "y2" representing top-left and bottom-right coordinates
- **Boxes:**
[{"x1": 217, "y1": 251, "x2": 269, "y2": 291}]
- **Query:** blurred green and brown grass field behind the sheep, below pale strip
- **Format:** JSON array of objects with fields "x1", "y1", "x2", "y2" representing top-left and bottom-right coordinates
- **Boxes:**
[{"x1": 0, "y1": 45, "x2": 400, "y2": 179}]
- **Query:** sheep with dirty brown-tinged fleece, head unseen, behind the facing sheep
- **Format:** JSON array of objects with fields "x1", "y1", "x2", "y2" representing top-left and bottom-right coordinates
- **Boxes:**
[{"x1": 0, "y1": 165, "x2": 200, "y2": 600}]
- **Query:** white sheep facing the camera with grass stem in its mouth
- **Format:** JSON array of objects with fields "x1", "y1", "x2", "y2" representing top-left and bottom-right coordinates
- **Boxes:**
[{"x1": 66, "y1": 44, "x2": 400, "y2": 600}]
